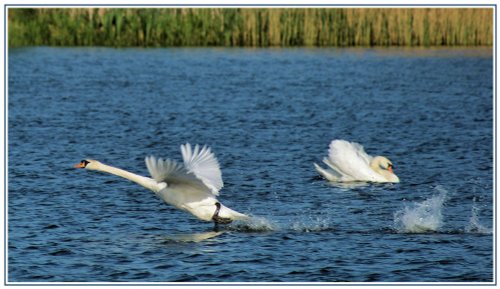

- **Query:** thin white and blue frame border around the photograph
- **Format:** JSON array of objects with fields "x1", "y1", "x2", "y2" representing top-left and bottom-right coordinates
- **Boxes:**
[{"x1": 0, "y1": 0, "x2": 499, "y2": 288}]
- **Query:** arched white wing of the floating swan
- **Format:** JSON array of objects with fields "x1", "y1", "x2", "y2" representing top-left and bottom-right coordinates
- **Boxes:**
[{"x1": 324, "y1": 140, "x2": 385, "y2": 182}]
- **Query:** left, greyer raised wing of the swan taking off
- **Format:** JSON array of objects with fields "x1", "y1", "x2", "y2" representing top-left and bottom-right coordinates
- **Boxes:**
[{"x1": 145, "y1": 156, "x2": 207, "y2": 189}]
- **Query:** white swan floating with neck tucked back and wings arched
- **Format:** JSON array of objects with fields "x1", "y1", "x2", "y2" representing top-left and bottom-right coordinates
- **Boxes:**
[{"x1": 314, "y1": 140, "x2": 399, "y2": 183}]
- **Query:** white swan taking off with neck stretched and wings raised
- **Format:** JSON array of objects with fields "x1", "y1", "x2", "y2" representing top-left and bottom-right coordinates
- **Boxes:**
[{"x1": 74, "y1": 143, "x2": 248, "y2": 225}]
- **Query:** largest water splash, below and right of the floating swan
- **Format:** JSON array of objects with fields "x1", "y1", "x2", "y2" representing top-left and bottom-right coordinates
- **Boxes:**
[{"x1": 394, "y1": 186, "x2": 447, "y2": 233}]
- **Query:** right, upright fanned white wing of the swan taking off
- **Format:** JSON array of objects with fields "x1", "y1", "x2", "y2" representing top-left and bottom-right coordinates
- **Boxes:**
[{"x1": 181, "y1": 143, "x2": 224, "y2": 196}]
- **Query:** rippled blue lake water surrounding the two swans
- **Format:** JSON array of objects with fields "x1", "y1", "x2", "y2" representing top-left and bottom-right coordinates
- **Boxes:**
[{"x1": 7, "y1": 47, "x2": 495, "y2": 283}]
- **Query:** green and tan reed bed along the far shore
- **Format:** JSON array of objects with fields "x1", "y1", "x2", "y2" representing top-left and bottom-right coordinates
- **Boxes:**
[{"x1": 8, "y1": 7, "x2": 493, "y2": 47}]
